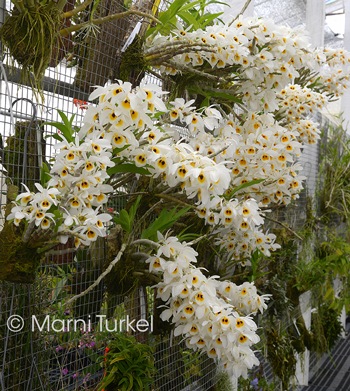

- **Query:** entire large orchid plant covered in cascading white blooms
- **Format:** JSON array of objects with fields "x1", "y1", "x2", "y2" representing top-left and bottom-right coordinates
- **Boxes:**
[{"x1": 8, "y1": 13, "x2": 350, "y2": 377}]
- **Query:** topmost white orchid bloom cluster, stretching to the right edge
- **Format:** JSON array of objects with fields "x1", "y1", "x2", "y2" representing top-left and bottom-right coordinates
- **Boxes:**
[{"x1": 145, "y1": 16, "x2": 350, "y2": 108}]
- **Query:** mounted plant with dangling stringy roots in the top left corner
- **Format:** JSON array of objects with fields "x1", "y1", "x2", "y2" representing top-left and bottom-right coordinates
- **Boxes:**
[{"x1": 0, "y1": 0, "x2": 159, "y2": 98}]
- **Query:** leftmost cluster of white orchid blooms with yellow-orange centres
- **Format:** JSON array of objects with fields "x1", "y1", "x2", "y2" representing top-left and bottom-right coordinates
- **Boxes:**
[{"x1": 7, "y1": 131, "x2": 114, "y2": 247}]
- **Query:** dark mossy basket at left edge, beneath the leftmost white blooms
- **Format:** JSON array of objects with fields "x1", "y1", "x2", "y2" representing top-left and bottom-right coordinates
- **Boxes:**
[{"x1": 0, "y1": 222, "x2": 41, "y2": 284}]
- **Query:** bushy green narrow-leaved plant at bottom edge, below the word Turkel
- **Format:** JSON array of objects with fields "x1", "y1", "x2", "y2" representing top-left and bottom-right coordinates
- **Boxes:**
[{"x1": 98, "y1": 334, "x2": 155, "y2": 391}]
